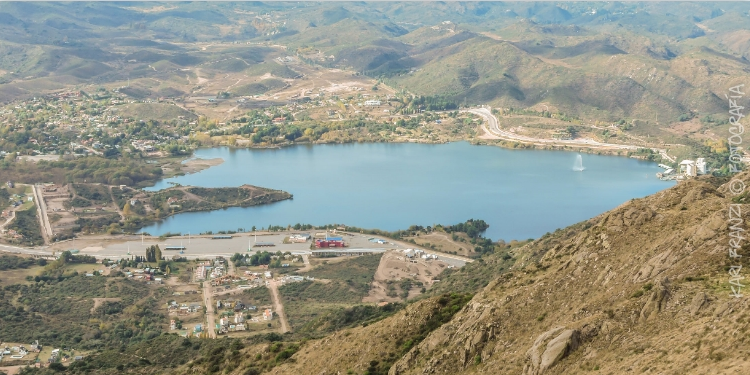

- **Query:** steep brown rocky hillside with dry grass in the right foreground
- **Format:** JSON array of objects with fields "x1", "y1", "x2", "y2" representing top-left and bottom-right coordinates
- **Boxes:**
[{"x1": 262, "y1": 174, "x2": 750, "y2": 375}]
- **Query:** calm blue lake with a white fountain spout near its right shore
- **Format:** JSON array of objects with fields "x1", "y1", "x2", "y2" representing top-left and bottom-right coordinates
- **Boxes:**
[{"x1": 144, "y1": 142, "x2": 674, "y2": 241}]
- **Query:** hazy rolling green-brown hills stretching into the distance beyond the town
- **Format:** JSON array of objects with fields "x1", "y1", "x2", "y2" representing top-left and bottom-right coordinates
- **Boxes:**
[{"x1": 0, "y1": 2, "x2": 750, "y2": 129}]
